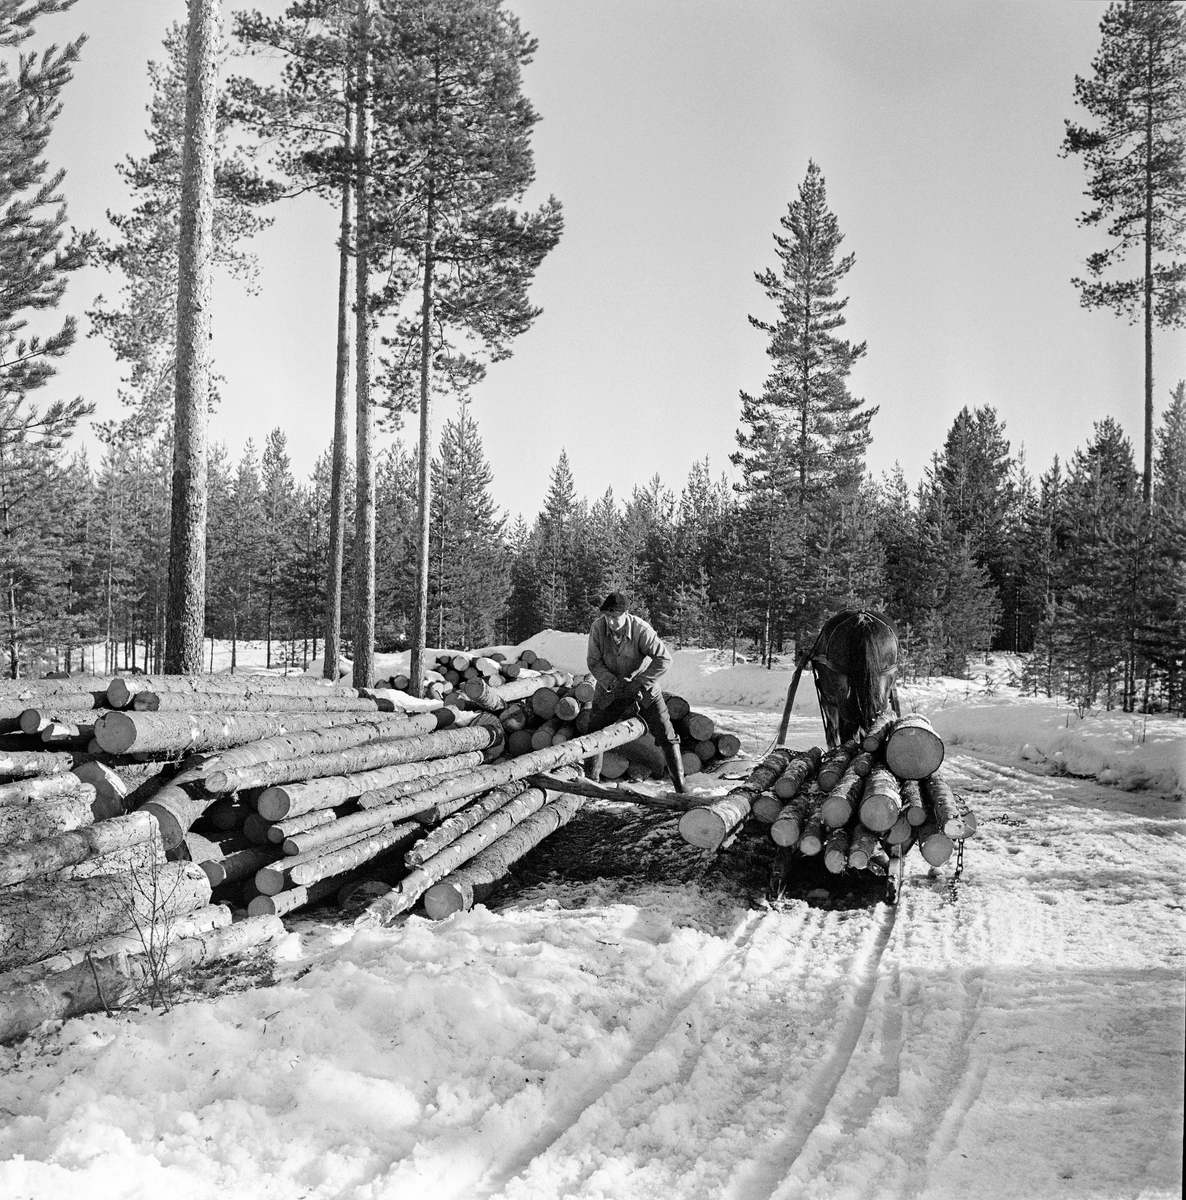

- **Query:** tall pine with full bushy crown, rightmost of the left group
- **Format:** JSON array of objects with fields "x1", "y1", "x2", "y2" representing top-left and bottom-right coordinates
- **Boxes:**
[{"x1": 375, "y1": 0, "x2": 562, "y2": 688}]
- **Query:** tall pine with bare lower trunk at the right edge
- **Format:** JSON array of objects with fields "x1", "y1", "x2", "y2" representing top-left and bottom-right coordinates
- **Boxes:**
[{"x1": 1062, "y1": 0, "x2": 1186, "y2": 509}]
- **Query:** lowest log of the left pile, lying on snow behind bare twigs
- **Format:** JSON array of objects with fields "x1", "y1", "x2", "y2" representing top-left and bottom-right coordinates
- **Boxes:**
[{"x1": 0, "y1": 917, "x2": 284, "y2": 1040}]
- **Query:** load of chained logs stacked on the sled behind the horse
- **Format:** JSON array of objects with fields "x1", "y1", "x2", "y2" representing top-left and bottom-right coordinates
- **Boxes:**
[{"x1": 679, "y1": 714, "x2": 976, "y2": 875}]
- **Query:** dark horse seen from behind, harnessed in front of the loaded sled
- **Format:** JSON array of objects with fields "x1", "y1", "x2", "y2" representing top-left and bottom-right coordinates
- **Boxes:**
[{"x1": 778, "y1": 608, "x2": 902, "y2": 746}]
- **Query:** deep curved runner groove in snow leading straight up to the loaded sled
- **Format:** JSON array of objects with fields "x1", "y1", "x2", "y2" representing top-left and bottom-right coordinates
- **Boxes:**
[{"x1": 723, "y1": 905, "x2": 902, "y2": 1200}]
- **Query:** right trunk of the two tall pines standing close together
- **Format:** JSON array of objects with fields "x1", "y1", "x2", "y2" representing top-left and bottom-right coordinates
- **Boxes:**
[{"x1": 354, "y1": 0, "x2": 375, "y2": 688}]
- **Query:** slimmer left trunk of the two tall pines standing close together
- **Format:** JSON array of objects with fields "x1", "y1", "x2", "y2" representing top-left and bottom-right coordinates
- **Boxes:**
[{"x1": 313, "y1": 56, "x2": 354, "y2": 679}]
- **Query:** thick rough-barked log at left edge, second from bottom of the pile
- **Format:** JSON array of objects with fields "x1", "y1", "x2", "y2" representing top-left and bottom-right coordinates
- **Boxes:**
[{"x1": 0, "y1": 863, "x2": 210, "y2": 970}]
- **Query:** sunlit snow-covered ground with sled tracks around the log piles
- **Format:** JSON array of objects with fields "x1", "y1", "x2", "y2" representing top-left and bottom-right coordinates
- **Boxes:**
[{"x1": 0, "y1": 635, "x2": 1186, "y2": 1200}]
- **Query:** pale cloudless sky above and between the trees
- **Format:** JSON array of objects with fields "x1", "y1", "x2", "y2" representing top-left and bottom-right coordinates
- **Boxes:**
[{"x1": 34, "y1": 0, "x2": 1186, "y2": 518}]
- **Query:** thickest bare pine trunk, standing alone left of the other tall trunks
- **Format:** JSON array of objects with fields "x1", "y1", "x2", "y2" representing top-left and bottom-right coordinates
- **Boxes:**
[{"x1": 164, "y1": 0, "x2": 220, "y2": 674}]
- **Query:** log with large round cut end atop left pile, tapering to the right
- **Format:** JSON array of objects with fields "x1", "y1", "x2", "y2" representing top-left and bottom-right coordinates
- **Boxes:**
[{"x1": 95, "y1": 712, "x2": 407, "y2": 754}]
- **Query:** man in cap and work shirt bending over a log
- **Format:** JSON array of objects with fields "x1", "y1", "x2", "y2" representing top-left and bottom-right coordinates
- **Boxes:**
[{"x1": 586, "y1": 592, "x2": 688, "y2": 792}]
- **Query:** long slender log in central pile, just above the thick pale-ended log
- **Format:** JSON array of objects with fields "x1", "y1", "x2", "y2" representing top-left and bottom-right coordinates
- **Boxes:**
[{"x1": 213, "y1": 716, "x2": 503, "y2": 801}]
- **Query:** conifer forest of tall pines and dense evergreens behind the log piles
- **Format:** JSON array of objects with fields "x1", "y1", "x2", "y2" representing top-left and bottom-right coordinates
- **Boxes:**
[{"x1": 0, "y1": 0, "x2": 1186, "y2": 713}]
